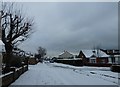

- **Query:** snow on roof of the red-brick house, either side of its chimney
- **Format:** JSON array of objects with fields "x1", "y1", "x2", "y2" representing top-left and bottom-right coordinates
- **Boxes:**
[{"x1": 82, "y1": 50, "x2": 109, "y2": 57}]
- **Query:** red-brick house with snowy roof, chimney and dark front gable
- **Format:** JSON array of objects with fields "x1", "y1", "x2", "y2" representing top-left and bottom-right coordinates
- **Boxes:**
[{"x1": 78, "y1": 50, "x2": 109, "y2": 64}]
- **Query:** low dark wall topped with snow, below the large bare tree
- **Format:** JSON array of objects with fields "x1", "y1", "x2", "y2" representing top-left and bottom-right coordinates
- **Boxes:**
[{"x1": 1, "y1": 65, "x2": 28, "y2": 87}]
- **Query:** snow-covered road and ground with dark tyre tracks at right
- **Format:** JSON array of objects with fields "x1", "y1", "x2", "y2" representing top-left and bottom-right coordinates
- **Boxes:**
[{"x1": 11, "y1": 63, "x2": 120, "y2": 85}]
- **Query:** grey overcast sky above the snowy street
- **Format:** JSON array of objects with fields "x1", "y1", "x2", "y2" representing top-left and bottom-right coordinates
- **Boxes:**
[{"x1": 19, "y1": 2, "x2": 118, "y2": 56}]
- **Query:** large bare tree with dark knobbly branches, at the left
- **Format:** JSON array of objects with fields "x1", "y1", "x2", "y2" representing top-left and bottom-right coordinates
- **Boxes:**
[{"x1": 0, "y1": 3, "x2": 33, "y2": 64}]
